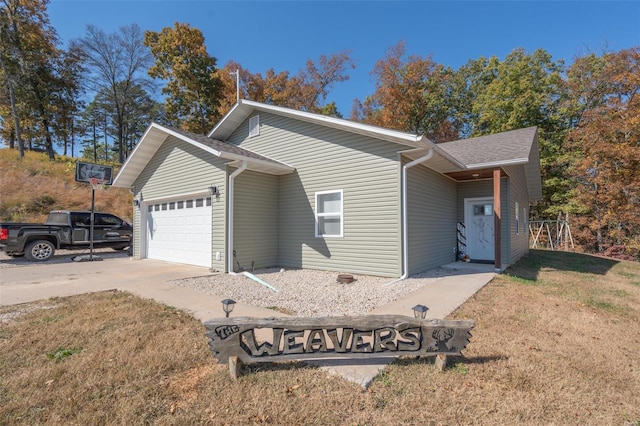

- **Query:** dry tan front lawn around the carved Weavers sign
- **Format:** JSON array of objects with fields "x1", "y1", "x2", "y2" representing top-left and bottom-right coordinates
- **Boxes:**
[{"x1": 0, "y1": 251, "x2": 640, "y2": 425}]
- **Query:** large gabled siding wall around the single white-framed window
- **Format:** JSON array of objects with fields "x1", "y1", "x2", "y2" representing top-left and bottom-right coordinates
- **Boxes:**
[{"x1": 228, "y1": 113, "x2": 403, "y2": 277}]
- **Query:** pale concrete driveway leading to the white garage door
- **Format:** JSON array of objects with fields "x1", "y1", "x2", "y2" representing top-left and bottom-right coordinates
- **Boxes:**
[{"x1": 0, "y1": 250, "x2": 277, "y2": 321}]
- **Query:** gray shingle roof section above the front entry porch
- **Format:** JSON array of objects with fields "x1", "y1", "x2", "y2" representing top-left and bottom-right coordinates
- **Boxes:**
[{"x1": 437, "y1": 127, "x2": 537, "y2": 168}]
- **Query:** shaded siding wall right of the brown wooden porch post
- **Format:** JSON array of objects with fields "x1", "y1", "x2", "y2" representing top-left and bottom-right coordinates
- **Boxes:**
[{"x1": 504, "y1": 166, "x2": 529, "y2": 264}]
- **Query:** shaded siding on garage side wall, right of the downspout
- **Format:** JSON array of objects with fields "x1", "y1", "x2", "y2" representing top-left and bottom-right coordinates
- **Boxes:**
[{"x1": 230, "y1": 169, "x2": 278, "y2": 270}]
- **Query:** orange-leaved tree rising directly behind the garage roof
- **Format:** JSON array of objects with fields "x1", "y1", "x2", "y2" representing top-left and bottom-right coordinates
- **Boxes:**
[{"x1": 144, "y1": 22, "x2": 222, "y2": 134}]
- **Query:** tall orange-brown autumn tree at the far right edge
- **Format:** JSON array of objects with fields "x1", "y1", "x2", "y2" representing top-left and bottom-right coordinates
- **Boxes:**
[{"x1": 568, "y1": 47, "x2": 640, "y2": 256}]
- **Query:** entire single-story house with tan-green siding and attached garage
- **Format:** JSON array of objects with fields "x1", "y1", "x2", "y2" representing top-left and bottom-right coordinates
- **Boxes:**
[{"x1": 113, "y1": 100, "x2": 542, "y2": 278}]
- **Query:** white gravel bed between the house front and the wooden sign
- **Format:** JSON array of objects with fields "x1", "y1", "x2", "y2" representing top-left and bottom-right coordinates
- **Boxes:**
[{"x1": 176, "y1": 268, "x2": 453, "y2": 317}]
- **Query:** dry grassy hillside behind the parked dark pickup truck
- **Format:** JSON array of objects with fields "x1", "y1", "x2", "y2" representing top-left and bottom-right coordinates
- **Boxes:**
[{"x1": 0, "y1": 148, "x2": 133, "y2": 222}]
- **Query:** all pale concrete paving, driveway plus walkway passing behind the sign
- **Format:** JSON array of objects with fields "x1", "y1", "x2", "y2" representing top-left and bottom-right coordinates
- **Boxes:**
[{"x1": 0, "y1": 257, "x2": 495, "y2": 387}]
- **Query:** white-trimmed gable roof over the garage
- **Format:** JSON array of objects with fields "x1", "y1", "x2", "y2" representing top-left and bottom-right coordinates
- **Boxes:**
[{"x1": 112, "y1": 123, "x2": 295, "y2": 188}]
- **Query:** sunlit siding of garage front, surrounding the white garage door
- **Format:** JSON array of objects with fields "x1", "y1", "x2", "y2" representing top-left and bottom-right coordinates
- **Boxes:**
[{"x1": 134, "y1": 136, "x2": 226, "y2": 271}]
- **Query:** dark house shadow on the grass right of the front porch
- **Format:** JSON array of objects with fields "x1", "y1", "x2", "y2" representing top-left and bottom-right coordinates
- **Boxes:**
[{"x1": 506, "y1": 250, "x2": 620, "y2": 280}]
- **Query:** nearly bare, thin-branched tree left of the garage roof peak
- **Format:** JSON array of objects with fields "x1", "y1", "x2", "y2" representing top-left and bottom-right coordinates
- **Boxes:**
[{"x1": 72, "y1": 24, "x2": 152, "y2": 163}]
